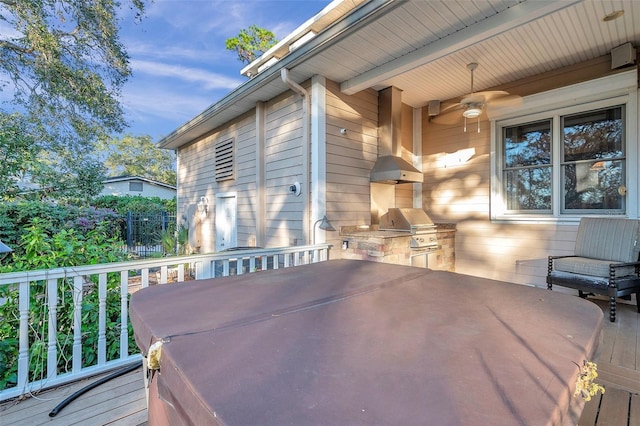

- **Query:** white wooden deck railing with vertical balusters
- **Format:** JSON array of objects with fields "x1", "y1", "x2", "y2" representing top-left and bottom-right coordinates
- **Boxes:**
[{"x1": 0, "y1": 244, "x2": 330, "y2": 401}]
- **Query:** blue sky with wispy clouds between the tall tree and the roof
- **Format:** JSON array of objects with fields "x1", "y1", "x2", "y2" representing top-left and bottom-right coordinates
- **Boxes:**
[{"x1": 120, "y1": 0, "x2": 330, "y2": 141}]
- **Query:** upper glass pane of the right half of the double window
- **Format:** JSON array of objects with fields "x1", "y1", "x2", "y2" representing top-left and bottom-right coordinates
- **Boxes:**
[{"x1": 563, "y1": 107, "x2": 623, "y2": 161}]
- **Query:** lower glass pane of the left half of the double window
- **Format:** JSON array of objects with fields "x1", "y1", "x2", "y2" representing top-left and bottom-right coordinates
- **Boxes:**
[{"x1": 505, "y1": 166, "x2": 551, "y2": 212}]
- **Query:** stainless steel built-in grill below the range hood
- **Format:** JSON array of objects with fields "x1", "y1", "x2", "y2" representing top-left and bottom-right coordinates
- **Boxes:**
[{"x1": 378, "y1": 208, "x2": 438, "y2": 249}]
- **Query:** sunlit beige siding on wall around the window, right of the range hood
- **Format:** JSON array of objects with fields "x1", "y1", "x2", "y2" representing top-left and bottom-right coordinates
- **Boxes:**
[{"x1": 422, "y1": 57, "x2": 624, "y2": 287}]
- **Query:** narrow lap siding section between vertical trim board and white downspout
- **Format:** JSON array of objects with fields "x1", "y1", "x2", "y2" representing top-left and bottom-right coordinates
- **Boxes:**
[{"x1": 264, "y1": 92, "x2": 308, "y2": 247}]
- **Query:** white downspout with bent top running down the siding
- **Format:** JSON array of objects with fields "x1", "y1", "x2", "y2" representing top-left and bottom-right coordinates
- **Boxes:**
[{"x1": 280, "y1": 68, "x2": 311, "y2": 244}]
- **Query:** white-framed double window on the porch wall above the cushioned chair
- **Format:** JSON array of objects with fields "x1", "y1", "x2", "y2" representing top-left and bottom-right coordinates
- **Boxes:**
[{"x1": 491, "y1": 70, "x2": 640, "y2": 222}]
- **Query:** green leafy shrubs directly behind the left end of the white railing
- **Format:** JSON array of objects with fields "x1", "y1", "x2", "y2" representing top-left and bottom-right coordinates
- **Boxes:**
[{"x1": 0, "y1": 219, "x2": 136, "y2": 389}]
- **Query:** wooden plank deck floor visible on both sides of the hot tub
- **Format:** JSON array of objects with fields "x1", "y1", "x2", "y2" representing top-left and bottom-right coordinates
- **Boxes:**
[{"x1": 0, "y1": 294, "x2": 640, "y2": 426}]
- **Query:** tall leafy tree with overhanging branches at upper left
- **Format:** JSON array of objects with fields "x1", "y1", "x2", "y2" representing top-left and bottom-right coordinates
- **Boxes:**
[{"x1": 0, "y1": 0, "x2": 144, "y2": 198}]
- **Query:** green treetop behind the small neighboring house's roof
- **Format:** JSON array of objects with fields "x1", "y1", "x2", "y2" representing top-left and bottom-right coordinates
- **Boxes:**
[{"x1": 98, "y1": 135, "x2": 177, "y2": 185}]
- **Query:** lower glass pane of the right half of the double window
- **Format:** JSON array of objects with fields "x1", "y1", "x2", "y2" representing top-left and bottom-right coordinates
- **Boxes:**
[{"x1": 563, "y1": 161, "x2": 624, "y2": 210}]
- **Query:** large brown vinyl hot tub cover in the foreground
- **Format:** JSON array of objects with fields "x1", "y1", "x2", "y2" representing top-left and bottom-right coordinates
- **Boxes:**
[{"x1": 130, "y1": 260, "x2": 603, "y2": 426}]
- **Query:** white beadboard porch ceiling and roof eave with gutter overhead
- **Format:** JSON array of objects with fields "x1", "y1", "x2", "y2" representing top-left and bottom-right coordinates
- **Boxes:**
[{"x1": 159, "y1": 0, "x2": 640, "y2": 149}]
